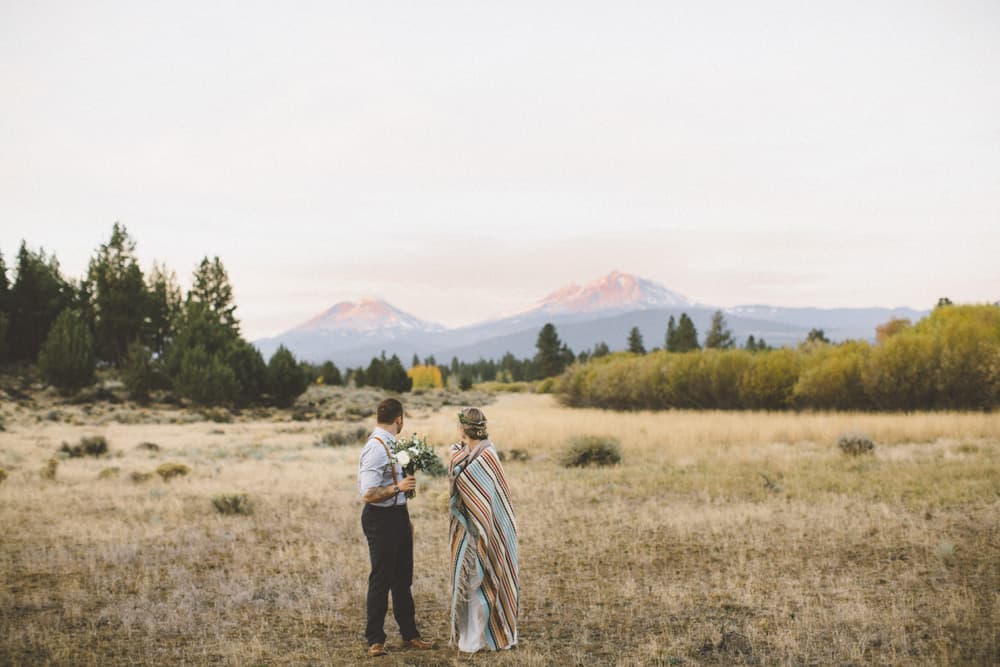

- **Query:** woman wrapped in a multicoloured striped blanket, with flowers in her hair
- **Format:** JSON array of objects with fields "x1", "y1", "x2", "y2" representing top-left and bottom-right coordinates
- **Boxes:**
[{"x1": 448, "y1": 408, "x2": 518, "y2": 653}]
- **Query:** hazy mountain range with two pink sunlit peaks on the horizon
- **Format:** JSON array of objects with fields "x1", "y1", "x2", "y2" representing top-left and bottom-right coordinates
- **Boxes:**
[{"x1": 255, "y1": 271, "x2": 927, "y2": 367}]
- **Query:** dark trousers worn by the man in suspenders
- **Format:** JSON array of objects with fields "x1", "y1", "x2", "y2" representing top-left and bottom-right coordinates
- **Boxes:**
[{"x1": 361, "y1": 505, "x2": 420, "y2": 644}]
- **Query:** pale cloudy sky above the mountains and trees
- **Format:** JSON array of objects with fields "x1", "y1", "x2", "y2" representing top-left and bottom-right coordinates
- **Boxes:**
[{"x1": 0, "y1": 0, "x2": 1000, "y2": 338}]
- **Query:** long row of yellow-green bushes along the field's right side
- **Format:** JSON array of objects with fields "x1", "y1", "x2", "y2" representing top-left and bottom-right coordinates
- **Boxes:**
[{"x1": 558, "y1": 299, "x2": 1000, "y2": 410}]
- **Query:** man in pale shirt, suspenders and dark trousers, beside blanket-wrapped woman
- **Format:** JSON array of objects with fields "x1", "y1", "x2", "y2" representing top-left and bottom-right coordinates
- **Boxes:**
[{"x1": 358, "y1": 398, "x2": 434, "y2": 658}]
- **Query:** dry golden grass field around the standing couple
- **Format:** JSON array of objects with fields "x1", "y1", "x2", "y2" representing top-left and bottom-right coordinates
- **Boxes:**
[{"x1": 0, "y1": 389, "x2": 1000, "y2": 666}]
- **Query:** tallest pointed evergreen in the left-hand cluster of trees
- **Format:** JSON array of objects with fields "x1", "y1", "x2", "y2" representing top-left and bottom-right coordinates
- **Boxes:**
[{"x1": 87, "y1": 222, "x2": 147, "y2": 365}]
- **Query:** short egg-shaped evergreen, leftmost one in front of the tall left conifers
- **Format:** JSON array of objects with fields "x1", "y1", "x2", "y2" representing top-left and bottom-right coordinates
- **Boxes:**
[{"x1": 38, "y1": 309, "x2": 97, "y2": 393}]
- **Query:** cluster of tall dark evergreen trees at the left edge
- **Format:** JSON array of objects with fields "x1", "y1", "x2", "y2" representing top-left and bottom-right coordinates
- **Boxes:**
[{"x1": 0, "y1": 223, "x2": 308, "y2": 406}]
